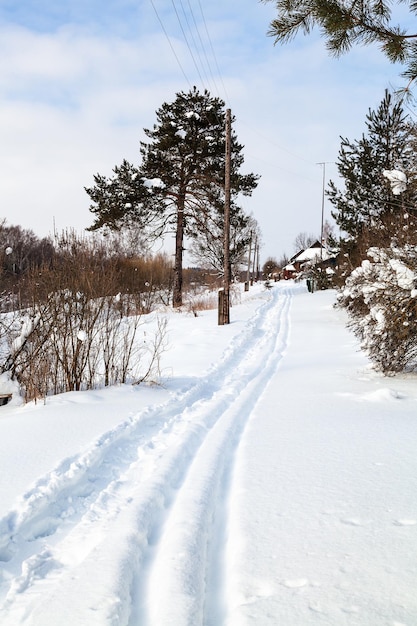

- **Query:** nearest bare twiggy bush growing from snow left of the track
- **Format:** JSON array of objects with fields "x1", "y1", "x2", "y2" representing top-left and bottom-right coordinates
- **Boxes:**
[{"x1": 3, "y1": 291, "x2": 165, "y2": 401}]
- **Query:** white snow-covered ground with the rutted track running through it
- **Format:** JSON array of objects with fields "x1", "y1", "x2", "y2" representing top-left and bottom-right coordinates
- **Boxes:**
[{"x1": 0, "y1": 283, "x2": 417, "y2": 626}]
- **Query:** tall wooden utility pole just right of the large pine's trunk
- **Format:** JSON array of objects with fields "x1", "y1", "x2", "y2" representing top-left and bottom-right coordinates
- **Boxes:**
[{"x1": 218, "y1": 109, "x2": 232, "y2": 325}]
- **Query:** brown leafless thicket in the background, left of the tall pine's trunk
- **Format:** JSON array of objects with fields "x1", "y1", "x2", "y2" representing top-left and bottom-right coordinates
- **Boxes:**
[{"x1": 0, "y1": 224, "x2": 172, "y2": 313}]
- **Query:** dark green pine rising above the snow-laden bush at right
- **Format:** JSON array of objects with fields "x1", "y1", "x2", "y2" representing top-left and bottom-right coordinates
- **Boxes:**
[{"x1": 327, "y1": 91, "x2": 417, "y2": 269}]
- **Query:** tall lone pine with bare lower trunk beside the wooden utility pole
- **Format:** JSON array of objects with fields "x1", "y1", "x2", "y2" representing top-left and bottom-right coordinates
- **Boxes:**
[{"x1": 86, "y1": 87, "x2": 258, "y2": 306}]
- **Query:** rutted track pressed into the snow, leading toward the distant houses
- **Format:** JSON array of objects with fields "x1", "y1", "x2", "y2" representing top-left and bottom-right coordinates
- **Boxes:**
[{"x1": 0, "y1": 289, "x2": 294, "y2": 626}]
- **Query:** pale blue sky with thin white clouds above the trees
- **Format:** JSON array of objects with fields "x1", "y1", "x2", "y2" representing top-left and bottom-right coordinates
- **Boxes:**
[{"x1": 0, "y1": 0, "x2": 410, "y2": 261}]
